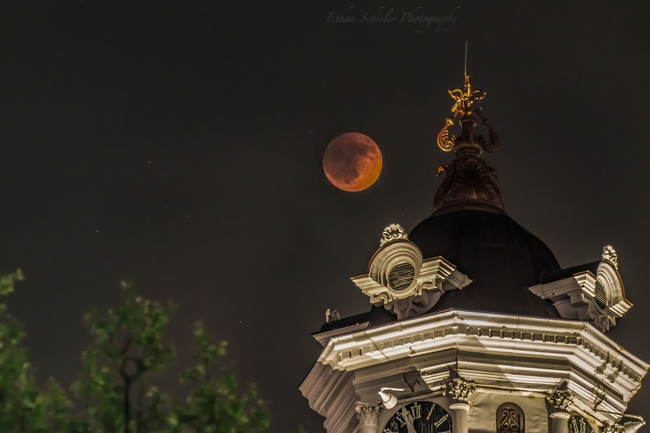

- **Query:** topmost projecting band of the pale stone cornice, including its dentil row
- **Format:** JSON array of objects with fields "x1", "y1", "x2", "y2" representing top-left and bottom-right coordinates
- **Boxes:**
[{"x1": 318, "y1": 310, "x2": 648, "y2": 374}]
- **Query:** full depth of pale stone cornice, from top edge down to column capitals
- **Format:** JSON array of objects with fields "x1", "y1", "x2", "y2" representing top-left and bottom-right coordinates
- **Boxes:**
[{"x1": 312, "y1": 310, "x2": 649, "y2": 413}]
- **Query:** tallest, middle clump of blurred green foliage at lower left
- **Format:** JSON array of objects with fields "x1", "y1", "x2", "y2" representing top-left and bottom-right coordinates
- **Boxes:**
[{"x1": 74, "y1": 282, "x2": 173, "y2": 433}]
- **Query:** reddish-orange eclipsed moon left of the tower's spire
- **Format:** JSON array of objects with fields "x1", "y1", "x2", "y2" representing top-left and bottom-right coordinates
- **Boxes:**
[{"x1": 323, "y1": 132, "x2": 383, "y2": 192}]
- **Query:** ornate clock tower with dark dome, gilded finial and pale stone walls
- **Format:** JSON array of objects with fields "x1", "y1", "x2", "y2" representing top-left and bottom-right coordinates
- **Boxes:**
[{"x1": 300, "y1": 76, "x2": 649, "y2": 433}]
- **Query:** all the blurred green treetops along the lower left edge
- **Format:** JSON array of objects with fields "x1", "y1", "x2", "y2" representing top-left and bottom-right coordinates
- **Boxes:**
[{"x1": 0, "y1": 271, "x2": 269, "y2": 433}]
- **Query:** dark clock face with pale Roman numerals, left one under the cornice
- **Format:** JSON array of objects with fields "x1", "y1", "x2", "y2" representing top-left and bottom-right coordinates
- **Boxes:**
[{"x1": 383, "y1": 401, "x2": 452, "y2": 433}]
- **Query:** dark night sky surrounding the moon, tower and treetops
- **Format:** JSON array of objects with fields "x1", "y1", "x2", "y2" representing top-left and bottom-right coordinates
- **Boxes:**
[{"x1": 0, "y1": 0, "x2": 650, "y2": 433}]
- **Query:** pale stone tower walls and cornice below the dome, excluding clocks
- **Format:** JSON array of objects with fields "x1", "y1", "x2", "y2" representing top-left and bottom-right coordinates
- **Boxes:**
[{"x1": 300, "y1": 310, "x2": 649, "y2": 433}]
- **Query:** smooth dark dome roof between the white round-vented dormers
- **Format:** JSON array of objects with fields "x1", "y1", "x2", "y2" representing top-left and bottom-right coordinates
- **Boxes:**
[{"x1": 409, "y1": 207, "x2": 560, "y2": 317}]
